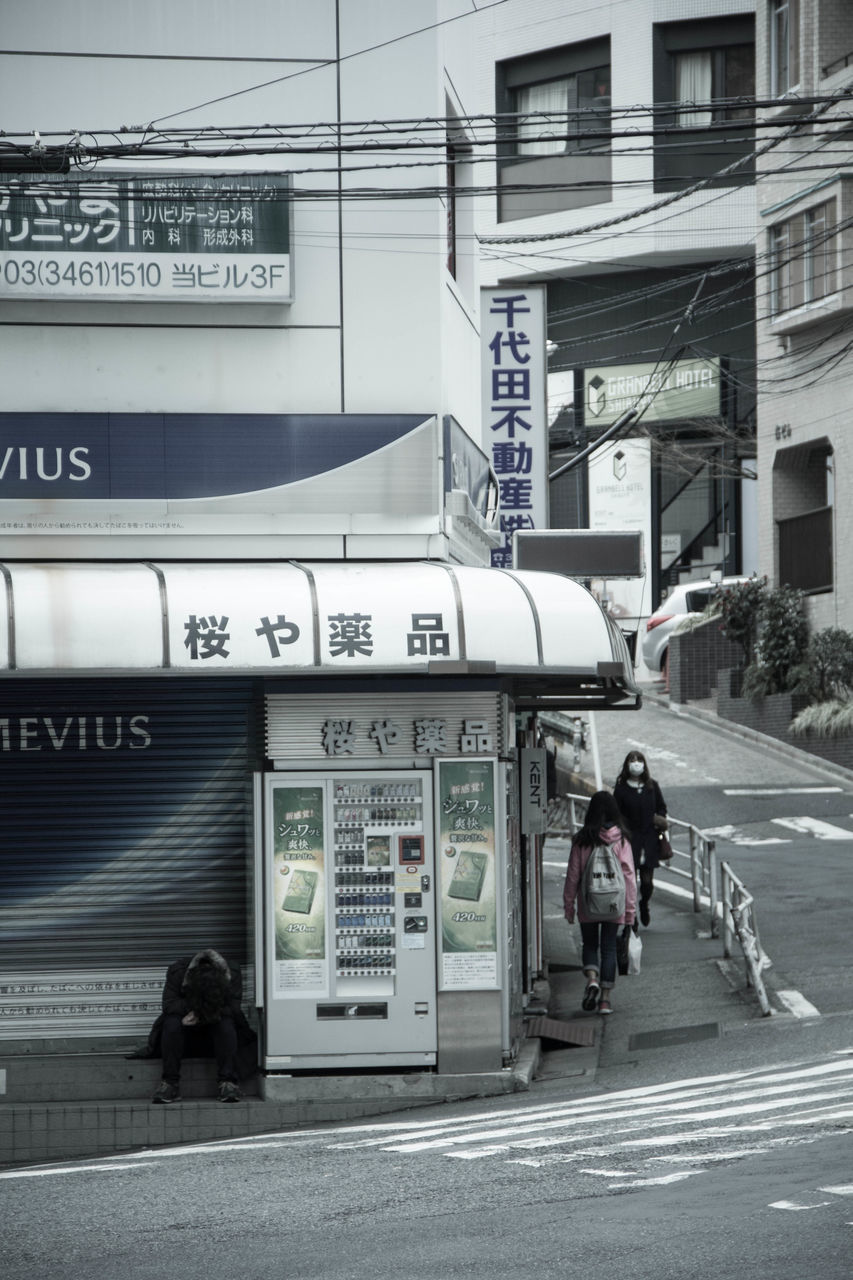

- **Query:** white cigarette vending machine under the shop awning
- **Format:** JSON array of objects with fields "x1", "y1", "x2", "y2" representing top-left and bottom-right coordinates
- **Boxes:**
[{"x1": 264, "y1": 769, "x2": 435, "y2": 1070}]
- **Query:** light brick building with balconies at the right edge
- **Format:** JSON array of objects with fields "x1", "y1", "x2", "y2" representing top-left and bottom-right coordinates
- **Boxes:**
[{"x1": 756, "y1": 0, "x2": 853, "y2": 630}]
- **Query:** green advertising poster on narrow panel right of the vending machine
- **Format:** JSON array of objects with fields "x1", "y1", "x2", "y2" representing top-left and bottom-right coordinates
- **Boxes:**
[{"x1": 437, "y1": 760, "x2": 498, "y2": 991}]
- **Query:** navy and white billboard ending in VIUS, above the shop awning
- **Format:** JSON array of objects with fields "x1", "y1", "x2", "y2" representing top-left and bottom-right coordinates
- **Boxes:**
[{"x1": 0, "y1": 413, "x2": 442, "y2": 558}]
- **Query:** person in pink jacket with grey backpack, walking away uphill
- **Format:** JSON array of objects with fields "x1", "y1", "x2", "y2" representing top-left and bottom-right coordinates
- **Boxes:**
[{"x1": 562, "y1": 791, "x2": 637, "y2": 1014}]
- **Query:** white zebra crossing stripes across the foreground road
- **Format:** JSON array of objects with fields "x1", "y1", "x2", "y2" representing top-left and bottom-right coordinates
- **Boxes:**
[{"x1": 8, "y1": 1048, "x2": 853, "y2": 1196}]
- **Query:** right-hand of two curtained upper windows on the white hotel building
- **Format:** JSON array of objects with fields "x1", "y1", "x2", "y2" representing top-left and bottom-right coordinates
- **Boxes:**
[{"x1": 674, "y1": 45, "x2": 756, "y2": 129}]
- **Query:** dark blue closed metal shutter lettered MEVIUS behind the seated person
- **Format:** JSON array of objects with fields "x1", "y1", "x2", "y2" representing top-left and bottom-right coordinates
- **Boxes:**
[{"x1": 0, "y1": 678, "x2": 255, "y2": 1034}]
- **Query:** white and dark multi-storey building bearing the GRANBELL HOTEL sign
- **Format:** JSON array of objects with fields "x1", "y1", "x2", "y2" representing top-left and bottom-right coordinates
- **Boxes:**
[{"x1": 471, "y1": 0, "x2": 757, "y2": 626}]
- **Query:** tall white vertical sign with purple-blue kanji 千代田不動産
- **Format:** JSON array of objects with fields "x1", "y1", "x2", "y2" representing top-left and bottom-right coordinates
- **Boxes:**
[{"x1": 480, "y1": 293, "x2": 548, "y2": 568}]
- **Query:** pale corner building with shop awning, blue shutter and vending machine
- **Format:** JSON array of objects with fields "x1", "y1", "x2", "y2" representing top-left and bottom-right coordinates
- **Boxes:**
[{"x1": 0, "y1": 0, "x2": 637, "y2": 1071}]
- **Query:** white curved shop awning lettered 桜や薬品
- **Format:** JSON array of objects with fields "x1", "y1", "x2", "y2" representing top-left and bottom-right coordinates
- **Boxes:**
[{"x1": 0, "y1": 561, "x2": 639, "y2": 708}]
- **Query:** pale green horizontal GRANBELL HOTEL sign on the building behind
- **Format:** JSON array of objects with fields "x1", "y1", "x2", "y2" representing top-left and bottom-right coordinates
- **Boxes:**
[{"x1": 584, "y1": 360, "x2": 721, "y2": 428}]
